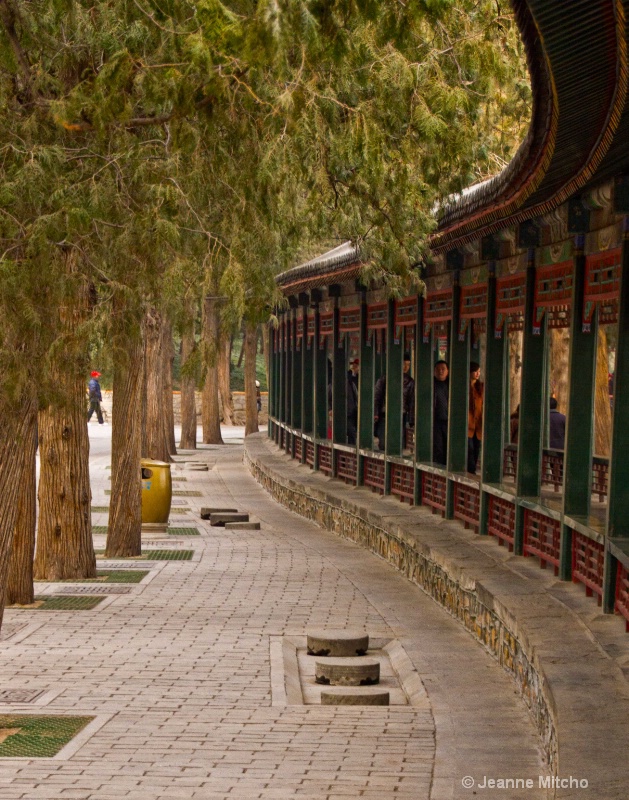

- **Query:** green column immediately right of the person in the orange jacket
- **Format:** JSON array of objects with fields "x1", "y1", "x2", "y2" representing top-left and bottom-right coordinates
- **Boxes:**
[{"x1": 479, "y1": 262, "x2": 508, "y2": 534}]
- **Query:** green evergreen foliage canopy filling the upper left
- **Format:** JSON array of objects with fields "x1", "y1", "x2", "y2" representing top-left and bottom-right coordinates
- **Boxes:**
[{"x1": 0, "y1": 0, "x2": 529, "y2": 410}]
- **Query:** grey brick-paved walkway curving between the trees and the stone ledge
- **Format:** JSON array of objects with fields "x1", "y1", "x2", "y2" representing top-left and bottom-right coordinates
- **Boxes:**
[{"x1": 0, "y1": 427, "x2": 546, "y2": 800}]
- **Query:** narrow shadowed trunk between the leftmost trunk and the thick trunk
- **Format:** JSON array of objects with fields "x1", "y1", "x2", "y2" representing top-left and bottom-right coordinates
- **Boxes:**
[{"x1": 5, "y1": 406, "x2": 37, "y2": 606}]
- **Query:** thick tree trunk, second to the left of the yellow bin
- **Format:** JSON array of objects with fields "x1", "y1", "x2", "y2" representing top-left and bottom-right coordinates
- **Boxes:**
[{"x1": 34, "y1": 376, "x2": 96, "y2": 581}]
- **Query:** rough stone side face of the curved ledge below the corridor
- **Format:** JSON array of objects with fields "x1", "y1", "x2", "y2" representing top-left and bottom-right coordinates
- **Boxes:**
[{"x1": 245, "y1": 437, "x2": 557, "y2": 773}]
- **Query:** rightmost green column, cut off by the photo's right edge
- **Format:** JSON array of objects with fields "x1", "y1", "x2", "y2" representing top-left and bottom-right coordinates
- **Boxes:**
[{"x1": 604, "y1": 217, "x2": 629, "y2": 539}]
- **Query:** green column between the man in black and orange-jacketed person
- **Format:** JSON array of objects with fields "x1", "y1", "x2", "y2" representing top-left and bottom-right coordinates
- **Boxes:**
[{"x1": 448, "y1": 276, "x2": 470, "y2": 472}]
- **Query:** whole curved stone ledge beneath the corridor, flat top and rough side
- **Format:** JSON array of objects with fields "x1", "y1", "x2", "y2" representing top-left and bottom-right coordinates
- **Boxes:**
[{"x1": 244, "y1": 434, "x2": 629, "y2": 800}]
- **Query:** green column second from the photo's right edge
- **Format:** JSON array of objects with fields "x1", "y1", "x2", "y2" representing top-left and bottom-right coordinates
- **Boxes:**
[{"x1": 559, "y1": 234, "x2": 598, "y2": 580}]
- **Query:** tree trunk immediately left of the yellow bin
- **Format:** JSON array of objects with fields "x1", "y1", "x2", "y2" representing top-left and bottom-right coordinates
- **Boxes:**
[{"x1": 105, "y1": 336, "x2": 144, "y2": 558}]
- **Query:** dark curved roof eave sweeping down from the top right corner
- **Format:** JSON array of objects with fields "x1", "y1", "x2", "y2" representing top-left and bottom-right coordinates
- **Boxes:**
[{"x1": 431, "y1": 0, "x2": 629, "y2": 252}]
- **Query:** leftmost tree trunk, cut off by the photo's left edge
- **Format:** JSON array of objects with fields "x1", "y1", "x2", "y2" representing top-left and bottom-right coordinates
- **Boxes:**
[{"x1": 0, "y1": 396, "x2": 36, "y2": 628}]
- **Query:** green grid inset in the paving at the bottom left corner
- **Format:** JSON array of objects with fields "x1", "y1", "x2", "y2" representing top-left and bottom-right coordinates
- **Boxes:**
[{"x1": 0, "y1": 714, "x2": 94, "y2": 758}]
